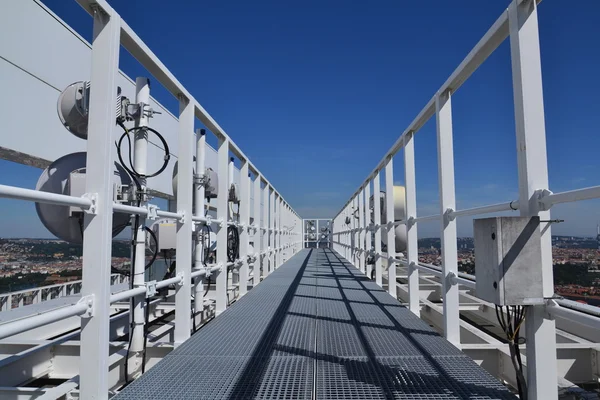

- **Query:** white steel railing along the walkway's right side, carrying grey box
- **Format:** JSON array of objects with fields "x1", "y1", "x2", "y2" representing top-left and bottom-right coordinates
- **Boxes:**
[{"x1": 333, "y1": 0, "x2": 600, "y2": 400}]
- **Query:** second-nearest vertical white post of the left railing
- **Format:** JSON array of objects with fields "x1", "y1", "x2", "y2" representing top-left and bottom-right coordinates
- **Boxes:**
[{"x1": 175, "y1": 96, "x2": 196, "y2": 346}]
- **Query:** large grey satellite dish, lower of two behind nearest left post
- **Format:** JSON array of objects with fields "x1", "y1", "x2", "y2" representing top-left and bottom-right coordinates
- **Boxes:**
[{"x1": 35, "y1": 152, "x2": 131, "y2": 244}]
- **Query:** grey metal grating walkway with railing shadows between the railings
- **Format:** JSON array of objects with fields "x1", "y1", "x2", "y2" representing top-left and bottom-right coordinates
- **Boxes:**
[{"x1": 114, "y1": 249, "x2": 516, "y2": 400}]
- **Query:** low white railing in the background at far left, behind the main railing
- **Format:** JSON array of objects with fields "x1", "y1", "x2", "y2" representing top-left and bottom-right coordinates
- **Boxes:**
[{"x1": 0, "y1": 274, "x2": 128, "y2": 311}]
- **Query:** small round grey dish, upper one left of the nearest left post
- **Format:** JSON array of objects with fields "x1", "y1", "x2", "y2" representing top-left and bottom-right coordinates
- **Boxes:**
[{"x1": 57, "y1": 81, "x2": 90, "y2": 139}]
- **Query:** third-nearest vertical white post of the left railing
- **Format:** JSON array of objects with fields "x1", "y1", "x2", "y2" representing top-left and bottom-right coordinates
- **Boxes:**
[{"x1": 215, "y1": 137, "x2": 229, "y2": 315}]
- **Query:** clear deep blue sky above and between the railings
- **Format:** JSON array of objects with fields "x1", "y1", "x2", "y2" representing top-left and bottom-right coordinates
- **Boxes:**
[{"x1": 0, "y1": 0, "x2": 600, "y2": 236}]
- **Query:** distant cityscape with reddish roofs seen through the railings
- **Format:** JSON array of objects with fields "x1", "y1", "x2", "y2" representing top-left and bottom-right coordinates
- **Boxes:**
[{"x1": 0, "y1": 236, "x2": 600, "y2": 305}]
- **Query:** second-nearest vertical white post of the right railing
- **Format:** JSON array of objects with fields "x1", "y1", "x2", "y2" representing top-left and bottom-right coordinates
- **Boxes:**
[{"x1": 435, "y1": 92, "x2": 460, "y2": 347}]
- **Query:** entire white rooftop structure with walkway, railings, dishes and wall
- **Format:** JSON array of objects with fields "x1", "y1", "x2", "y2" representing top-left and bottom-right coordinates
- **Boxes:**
[{"x1": 0, "y1": 0, "x2": 600, "y2": 400}]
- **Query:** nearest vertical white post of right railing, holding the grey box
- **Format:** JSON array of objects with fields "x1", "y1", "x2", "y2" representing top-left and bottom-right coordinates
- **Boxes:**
[{"x1": 508, "y1": 0, "x2": 558, "y2": 400}]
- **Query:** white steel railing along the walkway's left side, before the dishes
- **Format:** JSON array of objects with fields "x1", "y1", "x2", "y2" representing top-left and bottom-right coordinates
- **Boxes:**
[{"x1": 0, "y1": 0, "x2": 302, "y2": 399}]
